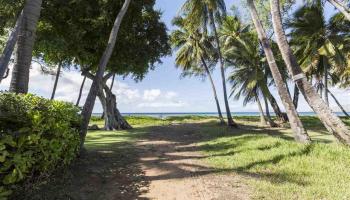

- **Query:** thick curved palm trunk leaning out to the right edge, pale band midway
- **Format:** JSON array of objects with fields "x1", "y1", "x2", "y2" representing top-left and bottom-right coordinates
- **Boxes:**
[{"x1": 270, "y1": 0, "x2": 350, "y2": 144}]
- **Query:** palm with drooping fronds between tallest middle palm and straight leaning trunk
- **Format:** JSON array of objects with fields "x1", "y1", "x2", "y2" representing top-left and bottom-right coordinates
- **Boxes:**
[{"x1": 220, "y1": 20, "x2": 277, "y2": 127}]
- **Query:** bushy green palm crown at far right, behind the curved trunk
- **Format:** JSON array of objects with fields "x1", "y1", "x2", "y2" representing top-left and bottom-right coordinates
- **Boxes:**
[{"x1": 287, "y1": 1, "x2": 350, "y2": 106}]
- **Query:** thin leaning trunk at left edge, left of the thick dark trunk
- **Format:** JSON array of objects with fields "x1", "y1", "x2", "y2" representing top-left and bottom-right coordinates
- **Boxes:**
[{"x1": 0, "y1": 11, "x2": 23, "y2": 83}]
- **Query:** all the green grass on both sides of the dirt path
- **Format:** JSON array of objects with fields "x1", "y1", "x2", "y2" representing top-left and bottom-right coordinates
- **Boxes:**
[{"x1": 15, "y1": 116, "x2": 350, "y2": 200}]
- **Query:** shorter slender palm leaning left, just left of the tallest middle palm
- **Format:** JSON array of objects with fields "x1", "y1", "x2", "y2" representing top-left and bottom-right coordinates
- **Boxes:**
[{"x1": 171, "y1": 17, "x2": 225, "y2": 124}]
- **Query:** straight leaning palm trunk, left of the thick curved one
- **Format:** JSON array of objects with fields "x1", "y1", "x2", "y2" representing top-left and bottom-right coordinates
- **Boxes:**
[{"x1": 247, "y1": 0, "x2": 310, "y2": 143}]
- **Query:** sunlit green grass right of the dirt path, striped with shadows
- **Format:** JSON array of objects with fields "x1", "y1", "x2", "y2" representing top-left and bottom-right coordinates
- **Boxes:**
[{"x1": 199, "y1": 117, "x2": 350, "y2": 200}]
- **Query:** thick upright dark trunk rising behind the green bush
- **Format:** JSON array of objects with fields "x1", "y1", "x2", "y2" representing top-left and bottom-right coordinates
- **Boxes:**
[{"x1": 10, "y1": 0, "x2": 42, "y2": 93}]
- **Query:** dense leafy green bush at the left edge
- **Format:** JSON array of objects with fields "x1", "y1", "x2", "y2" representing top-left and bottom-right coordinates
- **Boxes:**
[{"x1": 0, "y1": 93, "x2": 81, "y2": 199}]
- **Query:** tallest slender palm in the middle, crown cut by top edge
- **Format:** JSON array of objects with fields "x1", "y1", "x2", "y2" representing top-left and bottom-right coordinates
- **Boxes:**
[{"x1": 182, "y1": 0, "x2": 238, "y2": 127}]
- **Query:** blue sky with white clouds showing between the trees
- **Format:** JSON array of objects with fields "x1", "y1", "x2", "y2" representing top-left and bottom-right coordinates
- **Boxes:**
[{"x1": 0, "y1": 0, "x2": 350, "y2": 113}]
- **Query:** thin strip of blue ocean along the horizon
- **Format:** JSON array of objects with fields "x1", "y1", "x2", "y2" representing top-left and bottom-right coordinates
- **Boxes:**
[{"x1": 93, "y1": 112, "x2": 345, "y2": 118}]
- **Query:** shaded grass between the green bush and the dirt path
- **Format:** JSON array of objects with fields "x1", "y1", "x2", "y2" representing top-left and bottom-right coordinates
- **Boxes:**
[{"x1": 12, "y1": 128, "x2": 148, "y2": 200}]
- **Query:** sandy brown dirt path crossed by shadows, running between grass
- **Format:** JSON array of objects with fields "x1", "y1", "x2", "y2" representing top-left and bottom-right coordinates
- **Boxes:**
[{"x1": 137, "y1": 124, "x2": 249, "y2": 200}]
